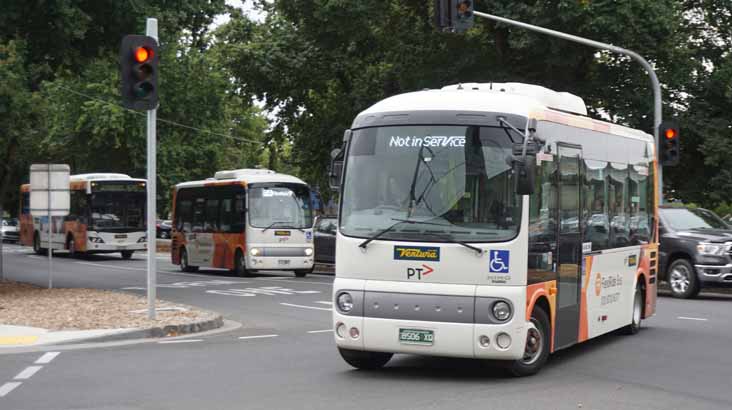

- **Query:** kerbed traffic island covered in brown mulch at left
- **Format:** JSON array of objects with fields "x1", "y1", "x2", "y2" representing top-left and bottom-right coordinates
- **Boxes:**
[{"x1": 0, "y1": 281, "x2": 223, "y2": 347}]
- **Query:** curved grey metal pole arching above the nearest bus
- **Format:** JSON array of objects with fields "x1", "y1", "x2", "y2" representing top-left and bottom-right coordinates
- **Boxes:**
[{"x1": 473, "y1": 11, "x2": 663, "y2": 204}]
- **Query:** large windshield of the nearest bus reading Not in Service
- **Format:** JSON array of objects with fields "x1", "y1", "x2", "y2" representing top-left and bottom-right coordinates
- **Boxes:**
[{"x1": 341, "y1": 125, "x2": 521, "y2": 242}]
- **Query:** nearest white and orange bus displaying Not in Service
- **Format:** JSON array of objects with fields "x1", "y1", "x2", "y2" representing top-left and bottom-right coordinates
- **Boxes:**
[{"x1": 331, "y1": 83, "x2": 658, "y2": 375}]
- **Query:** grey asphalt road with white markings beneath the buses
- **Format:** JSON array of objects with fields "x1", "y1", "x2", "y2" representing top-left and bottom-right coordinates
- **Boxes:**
[{"x1": 0, "y1": 245, "x2": 732, "y2": 410}]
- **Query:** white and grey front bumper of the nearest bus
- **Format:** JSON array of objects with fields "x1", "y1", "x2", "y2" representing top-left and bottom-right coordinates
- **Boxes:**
[{"x1": 333, "y1": 287, "x2": 530, "y2": 360}]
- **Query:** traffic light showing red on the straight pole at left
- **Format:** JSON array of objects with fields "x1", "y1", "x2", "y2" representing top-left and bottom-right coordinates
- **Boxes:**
[{"x1": 119, "y1": 34, "x2": 159, "y2": 110}]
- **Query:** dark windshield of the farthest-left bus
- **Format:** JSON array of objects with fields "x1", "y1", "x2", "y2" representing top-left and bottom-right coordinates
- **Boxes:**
[{"x1": 91, "y1": 182, "x2": 146, "y2": 231}]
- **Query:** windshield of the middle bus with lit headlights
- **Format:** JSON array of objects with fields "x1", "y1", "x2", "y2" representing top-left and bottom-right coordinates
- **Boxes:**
[{"x1": 249, "y1": 184, "x2": 313, "y2": 229}]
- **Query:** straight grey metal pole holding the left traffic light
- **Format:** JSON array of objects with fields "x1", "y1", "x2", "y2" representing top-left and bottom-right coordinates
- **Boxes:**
[{"x1": 145, "y1": 18, "x2": 158, "y2": 320}]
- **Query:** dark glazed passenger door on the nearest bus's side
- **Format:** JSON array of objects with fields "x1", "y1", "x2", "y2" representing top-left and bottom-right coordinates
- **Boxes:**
[{"x1": 554, "y1": 143, "x2": 582, "y2": 349}]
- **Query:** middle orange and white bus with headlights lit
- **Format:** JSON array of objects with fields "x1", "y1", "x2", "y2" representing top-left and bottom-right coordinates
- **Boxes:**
[{"x1": 171, "y1": 169, "x2": 314, "y2": 277}]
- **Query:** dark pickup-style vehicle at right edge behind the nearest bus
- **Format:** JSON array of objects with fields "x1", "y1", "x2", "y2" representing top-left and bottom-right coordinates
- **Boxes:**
[{"x1": 659, "y1": 206, "x2": 732, "y2": 299}]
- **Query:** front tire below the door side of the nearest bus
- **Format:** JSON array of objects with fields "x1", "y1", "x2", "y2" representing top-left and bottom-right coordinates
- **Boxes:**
[{"x1": 508, "y1": 306, "x2": 551, "y2": 377}]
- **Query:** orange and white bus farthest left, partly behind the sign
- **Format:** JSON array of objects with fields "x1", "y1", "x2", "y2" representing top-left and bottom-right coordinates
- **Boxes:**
[{"x1": 20, "y1": 173, "x2": 147, "y2": 259}]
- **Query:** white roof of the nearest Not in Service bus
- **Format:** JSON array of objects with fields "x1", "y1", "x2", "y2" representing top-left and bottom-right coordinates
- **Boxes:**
[{"x1": 352, "y1": 83, "x2": 653, "y2": 141}]
